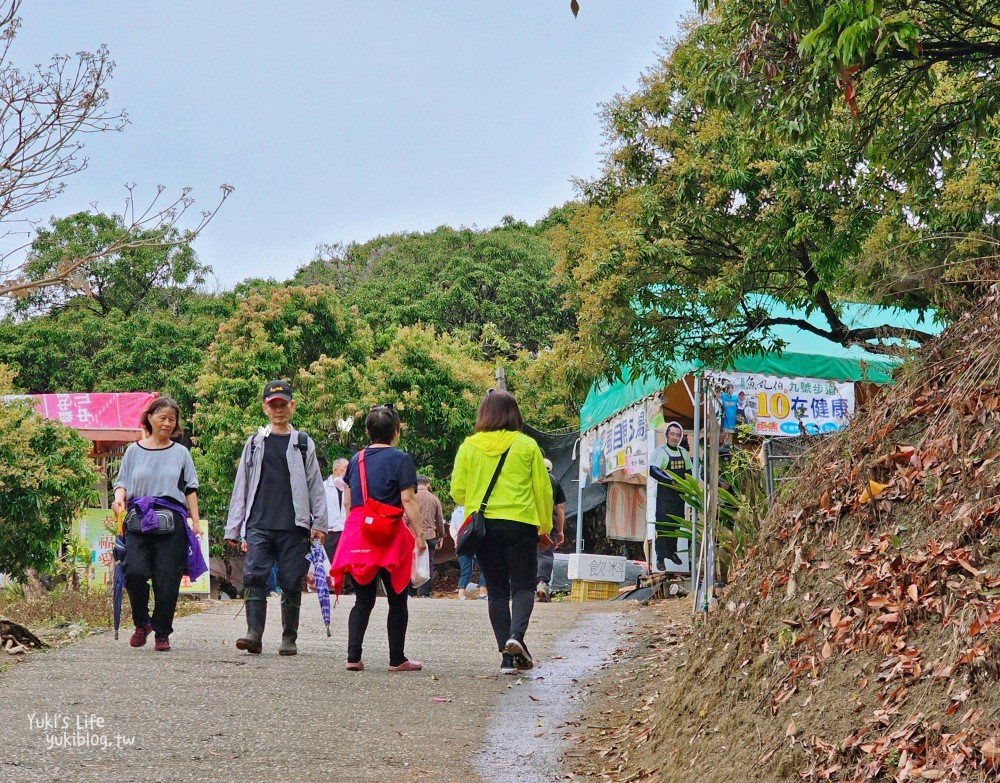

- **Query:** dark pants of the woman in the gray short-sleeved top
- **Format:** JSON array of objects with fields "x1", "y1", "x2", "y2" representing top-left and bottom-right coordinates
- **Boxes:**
[{"x1": 125, "y1": 514, "x2": 188, "y2": 638}]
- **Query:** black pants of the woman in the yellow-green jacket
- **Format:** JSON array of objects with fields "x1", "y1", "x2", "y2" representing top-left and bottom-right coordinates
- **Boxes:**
[{"x1": 476, "y1": 519, "x2": 538, "y2": 652}]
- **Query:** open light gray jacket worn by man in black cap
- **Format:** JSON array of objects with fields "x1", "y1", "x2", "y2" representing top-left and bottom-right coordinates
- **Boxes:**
[{"x1": 225, "y1": 427, "x2": 327, "y2": 540}]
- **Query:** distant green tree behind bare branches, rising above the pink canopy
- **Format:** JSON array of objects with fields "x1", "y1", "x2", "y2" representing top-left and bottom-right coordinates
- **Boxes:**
[{"x1": 15, "y1": 212, "x2": 211, "y2": 316}]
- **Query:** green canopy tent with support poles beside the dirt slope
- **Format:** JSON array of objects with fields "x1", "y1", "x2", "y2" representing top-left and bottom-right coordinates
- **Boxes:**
[{"x1": 576, "y1": 301, "x2": 941, "y2": 552}]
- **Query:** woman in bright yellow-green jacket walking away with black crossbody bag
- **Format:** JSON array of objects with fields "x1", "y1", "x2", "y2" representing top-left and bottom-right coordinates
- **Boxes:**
[{"x1": 451, "y1": 390, "x2": 552, "y2": 674}]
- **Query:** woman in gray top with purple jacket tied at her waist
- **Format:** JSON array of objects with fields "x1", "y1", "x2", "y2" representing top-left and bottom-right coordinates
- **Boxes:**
[{"x1": 111, "y1": 397, "x2": 202, "y2": 652}]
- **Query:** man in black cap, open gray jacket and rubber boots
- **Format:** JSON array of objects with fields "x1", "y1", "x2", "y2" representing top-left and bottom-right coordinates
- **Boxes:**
[{"x1": 225, "y1": 381, "x2": 327, "y2": 655}]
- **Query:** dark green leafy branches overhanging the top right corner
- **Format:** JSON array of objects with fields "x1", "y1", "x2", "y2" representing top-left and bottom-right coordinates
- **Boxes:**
[{"x1": 699, "y1": 0, "x2": 1000, "y2": 137}]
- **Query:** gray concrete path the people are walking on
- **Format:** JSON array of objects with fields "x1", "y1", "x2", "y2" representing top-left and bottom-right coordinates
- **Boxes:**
[{"x1": 0, "y1": 595, "x2": 629, "y2": 783}]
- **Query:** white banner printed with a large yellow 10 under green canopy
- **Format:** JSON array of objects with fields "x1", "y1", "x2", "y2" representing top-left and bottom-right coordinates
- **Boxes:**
[{"x1": 706, "y1": 372, "x2": 854, "y2": 438}]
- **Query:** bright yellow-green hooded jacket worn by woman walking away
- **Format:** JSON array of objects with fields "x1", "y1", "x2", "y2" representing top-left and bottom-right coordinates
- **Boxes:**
[{"x1": 451, "y1": 430, "x2": 552, "y2": 533}]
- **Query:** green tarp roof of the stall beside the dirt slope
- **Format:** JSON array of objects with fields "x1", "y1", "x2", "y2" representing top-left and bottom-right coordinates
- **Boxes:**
[{"x1": 580, "y1": 303, "x2": 941, "y2": 432}]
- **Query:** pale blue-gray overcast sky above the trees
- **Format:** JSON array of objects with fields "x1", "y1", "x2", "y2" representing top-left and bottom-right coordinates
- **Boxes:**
[{"x1": 11, "y1": 0, "x2": 692, "y2": 287}]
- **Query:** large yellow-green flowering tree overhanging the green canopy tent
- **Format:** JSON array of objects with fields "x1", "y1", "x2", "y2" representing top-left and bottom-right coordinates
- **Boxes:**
[{"x1": 553, "y1": 16, "x2": 980, "y2": 374}]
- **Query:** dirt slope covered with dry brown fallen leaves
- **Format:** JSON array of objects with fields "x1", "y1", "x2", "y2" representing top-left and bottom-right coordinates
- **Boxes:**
[{"x1": 635, "y1": 297, "x2": 1000, "y2": 783}]
